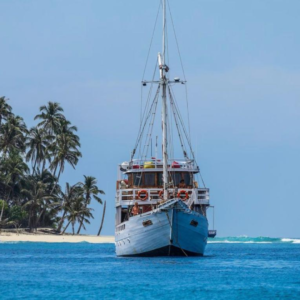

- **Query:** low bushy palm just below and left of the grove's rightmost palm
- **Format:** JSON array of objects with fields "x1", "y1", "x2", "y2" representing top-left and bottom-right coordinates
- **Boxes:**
[{"x1": 62, "y1": 197, "x2": 94, "y2": 235}]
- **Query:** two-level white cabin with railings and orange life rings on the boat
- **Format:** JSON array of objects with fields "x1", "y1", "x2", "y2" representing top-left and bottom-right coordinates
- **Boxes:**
[{"x1": 115, "y1": 158, "x2": 209, "y2": 228}]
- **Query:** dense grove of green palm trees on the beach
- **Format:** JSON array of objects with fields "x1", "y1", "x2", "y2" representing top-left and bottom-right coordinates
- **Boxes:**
[{"x1": 0, "y1": 97, "x2": 104, "y2": 234}]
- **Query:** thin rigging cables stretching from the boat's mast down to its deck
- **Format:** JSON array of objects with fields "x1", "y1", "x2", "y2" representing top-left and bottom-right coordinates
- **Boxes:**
[{"x1": 131, "y1": 0, "x2": 205, "y2": 189}]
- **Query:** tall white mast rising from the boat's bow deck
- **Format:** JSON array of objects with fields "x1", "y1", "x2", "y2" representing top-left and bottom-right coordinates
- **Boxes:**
[{"x1": 158, "y1": 0, "x2": 169, "y2": 200}]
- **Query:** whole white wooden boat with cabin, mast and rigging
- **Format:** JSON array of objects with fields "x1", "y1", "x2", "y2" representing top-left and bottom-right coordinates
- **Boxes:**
[{"x1": 115, "y1": 0, "x2": 216, "y2": 256}]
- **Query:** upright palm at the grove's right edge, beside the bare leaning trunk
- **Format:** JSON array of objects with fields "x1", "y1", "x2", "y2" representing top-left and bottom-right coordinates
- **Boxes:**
[{"x1": 77, "y1": 175, "x2": 105, "y2": 234}]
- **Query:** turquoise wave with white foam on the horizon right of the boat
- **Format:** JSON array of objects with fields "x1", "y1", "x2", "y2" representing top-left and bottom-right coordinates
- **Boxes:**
[{"x1": 207, "y1": 235, "x2": 300, "y2": 244}]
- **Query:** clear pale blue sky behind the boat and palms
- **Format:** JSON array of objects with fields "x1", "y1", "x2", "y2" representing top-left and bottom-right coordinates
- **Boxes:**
[{"x1": 0, "y1": 0, "x2": 300, "y2": 237}]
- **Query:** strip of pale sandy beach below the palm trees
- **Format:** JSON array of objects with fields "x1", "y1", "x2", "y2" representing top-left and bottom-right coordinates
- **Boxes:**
[{"x1": 0, "y1": 232, "x2": 115, "y2": 244}]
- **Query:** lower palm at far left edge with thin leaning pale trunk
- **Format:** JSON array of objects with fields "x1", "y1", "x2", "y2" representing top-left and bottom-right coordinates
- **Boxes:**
[{"x1": 0, "y1": 150, "x2": 29, "y2": 221}]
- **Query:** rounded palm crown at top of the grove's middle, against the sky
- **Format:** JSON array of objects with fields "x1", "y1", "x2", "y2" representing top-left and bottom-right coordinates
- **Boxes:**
[{"x1": 34, "y1": 102, "x2": 65, "y2": 134}]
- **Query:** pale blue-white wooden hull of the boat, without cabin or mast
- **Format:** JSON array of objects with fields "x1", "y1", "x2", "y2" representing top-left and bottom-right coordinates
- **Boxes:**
[{"x1": 116, "y1": 200, "x2": 208, "y2": 256}]
